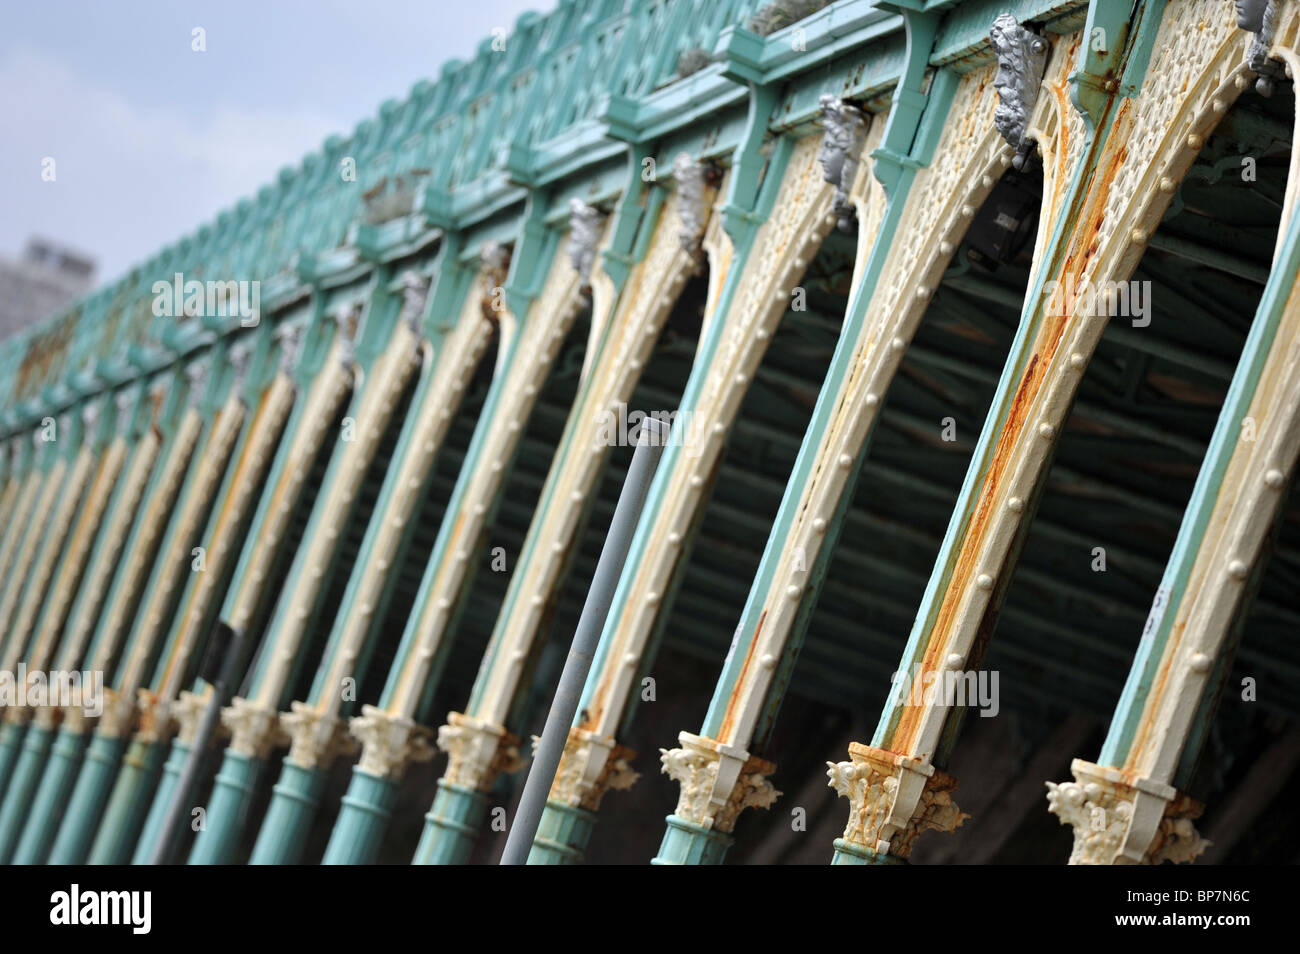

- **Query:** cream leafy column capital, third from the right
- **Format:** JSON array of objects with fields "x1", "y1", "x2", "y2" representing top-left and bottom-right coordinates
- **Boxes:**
[{"x1": 659, "y1": 732, "x2": 781, "y2": 832}]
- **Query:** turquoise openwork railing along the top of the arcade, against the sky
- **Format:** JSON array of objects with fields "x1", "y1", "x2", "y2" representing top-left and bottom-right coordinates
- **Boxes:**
[{"x1": 0, "y1": 0, "x2": 946, "y2": 421}]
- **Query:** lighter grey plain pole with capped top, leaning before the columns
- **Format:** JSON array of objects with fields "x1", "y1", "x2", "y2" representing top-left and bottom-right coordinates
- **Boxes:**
[{"x1": 501, "y1": 417, "x2": 668, "y2": 864}]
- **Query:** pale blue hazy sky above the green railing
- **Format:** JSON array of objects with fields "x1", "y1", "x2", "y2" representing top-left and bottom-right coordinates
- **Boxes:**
[{"x1": 0, "y1": 0, "x2": 556, "y2": 285}]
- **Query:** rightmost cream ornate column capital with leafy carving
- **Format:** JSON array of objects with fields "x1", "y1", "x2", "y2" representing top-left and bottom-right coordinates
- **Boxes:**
[{"x1": 1048, "y1": 759, "x2": 1209, "y2": 864}]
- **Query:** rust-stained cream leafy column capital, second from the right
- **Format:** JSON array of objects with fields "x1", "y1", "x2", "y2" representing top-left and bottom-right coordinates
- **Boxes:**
[{"x1": 826, "y1": 742, "x2": 970, "y2": 858}]
